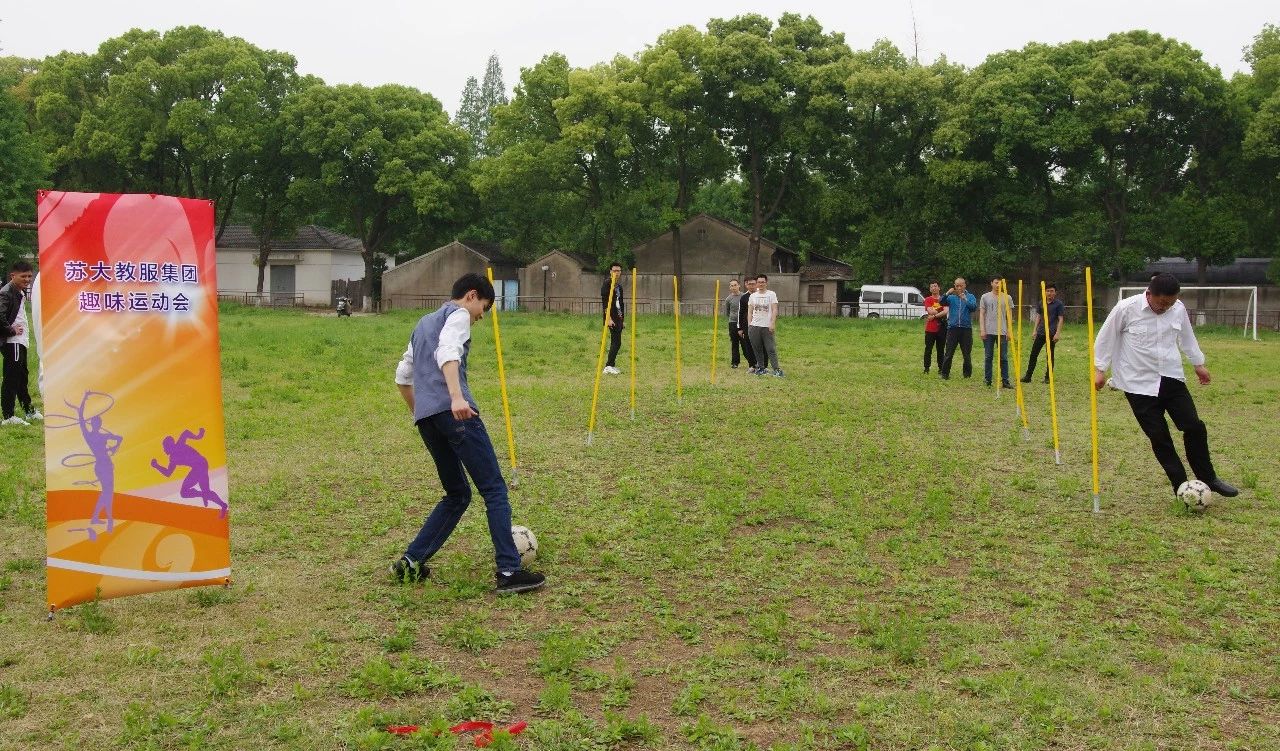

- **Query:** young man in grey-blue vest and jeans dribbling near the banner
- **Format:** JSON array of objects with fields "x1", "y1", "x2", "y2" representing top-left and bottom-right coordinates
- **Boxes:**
[{"x1": 392, "y1": 274, "x2": 545, "y2": 595}]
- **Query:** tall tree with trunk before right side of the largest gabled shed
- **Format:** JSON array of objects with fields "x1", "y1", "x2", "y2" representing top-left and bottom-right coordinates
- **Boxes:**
[{"x1": 700, "y1": 13, "x2": 850, "y2": 274}]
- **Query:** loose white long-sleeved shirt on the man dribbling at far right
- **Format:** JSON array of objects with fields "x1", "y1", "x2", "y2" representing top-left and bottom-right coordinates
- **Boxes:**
[{"x1": 1093, "y1": 294, "x2": 1204, "y2": 397}]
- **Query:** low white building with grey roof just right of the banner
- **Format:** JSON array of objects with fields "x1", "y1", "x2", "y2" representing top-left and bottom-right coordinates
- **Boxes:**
[{"x1": 218, "y1": 224, "x2": 367, "y2": 306}]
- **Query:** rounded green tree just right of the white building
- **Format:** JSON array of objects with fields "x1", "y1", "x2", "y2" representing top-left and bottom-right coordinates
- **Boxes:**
[{"x1": 283, "y1": 84, "x2": 470, "y2": 303}]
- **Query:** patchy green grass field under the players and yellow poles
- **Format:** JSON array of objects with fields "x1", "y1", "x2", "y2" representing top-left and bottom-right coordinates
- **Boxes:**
[{"x1": 0, "y1": 307, "x2": 1280, "y2": 751}]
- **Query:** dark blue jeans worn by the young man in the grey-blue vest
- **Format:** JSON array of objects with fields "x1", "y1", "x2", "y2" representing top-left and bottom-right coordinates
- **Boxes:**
[{"x1": 404, "y1": 412, "x2": 520, "y2": 571}]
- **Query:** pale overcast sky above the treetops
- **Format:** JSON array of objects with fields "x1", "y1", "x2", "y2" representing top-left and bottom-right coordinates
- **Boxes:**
[{"x1": 0, "y1": 0, "x2": 1280, "y2": 114}]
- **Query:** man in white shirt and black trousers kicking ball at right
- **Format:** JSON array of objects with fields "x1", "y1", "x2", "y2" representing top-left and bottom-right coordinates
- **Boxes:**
[{"x1": 1093, "y1": 274, "x2": 1239, "y2": 498}]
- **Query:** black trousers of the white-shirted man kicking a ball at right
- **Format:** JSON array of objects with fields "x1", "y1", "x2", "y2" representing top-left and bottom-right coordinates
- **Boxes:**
[{"x1": 1125, "y1": 377, "x2": 1217, "y2": 490}]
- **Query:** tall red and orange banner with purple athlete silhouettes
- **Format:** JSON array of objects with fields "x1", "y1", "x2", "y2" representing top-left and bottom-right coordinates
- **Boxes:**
[{"x1": 38, "y1": 191, "x2": 230, "y2": 612}]
